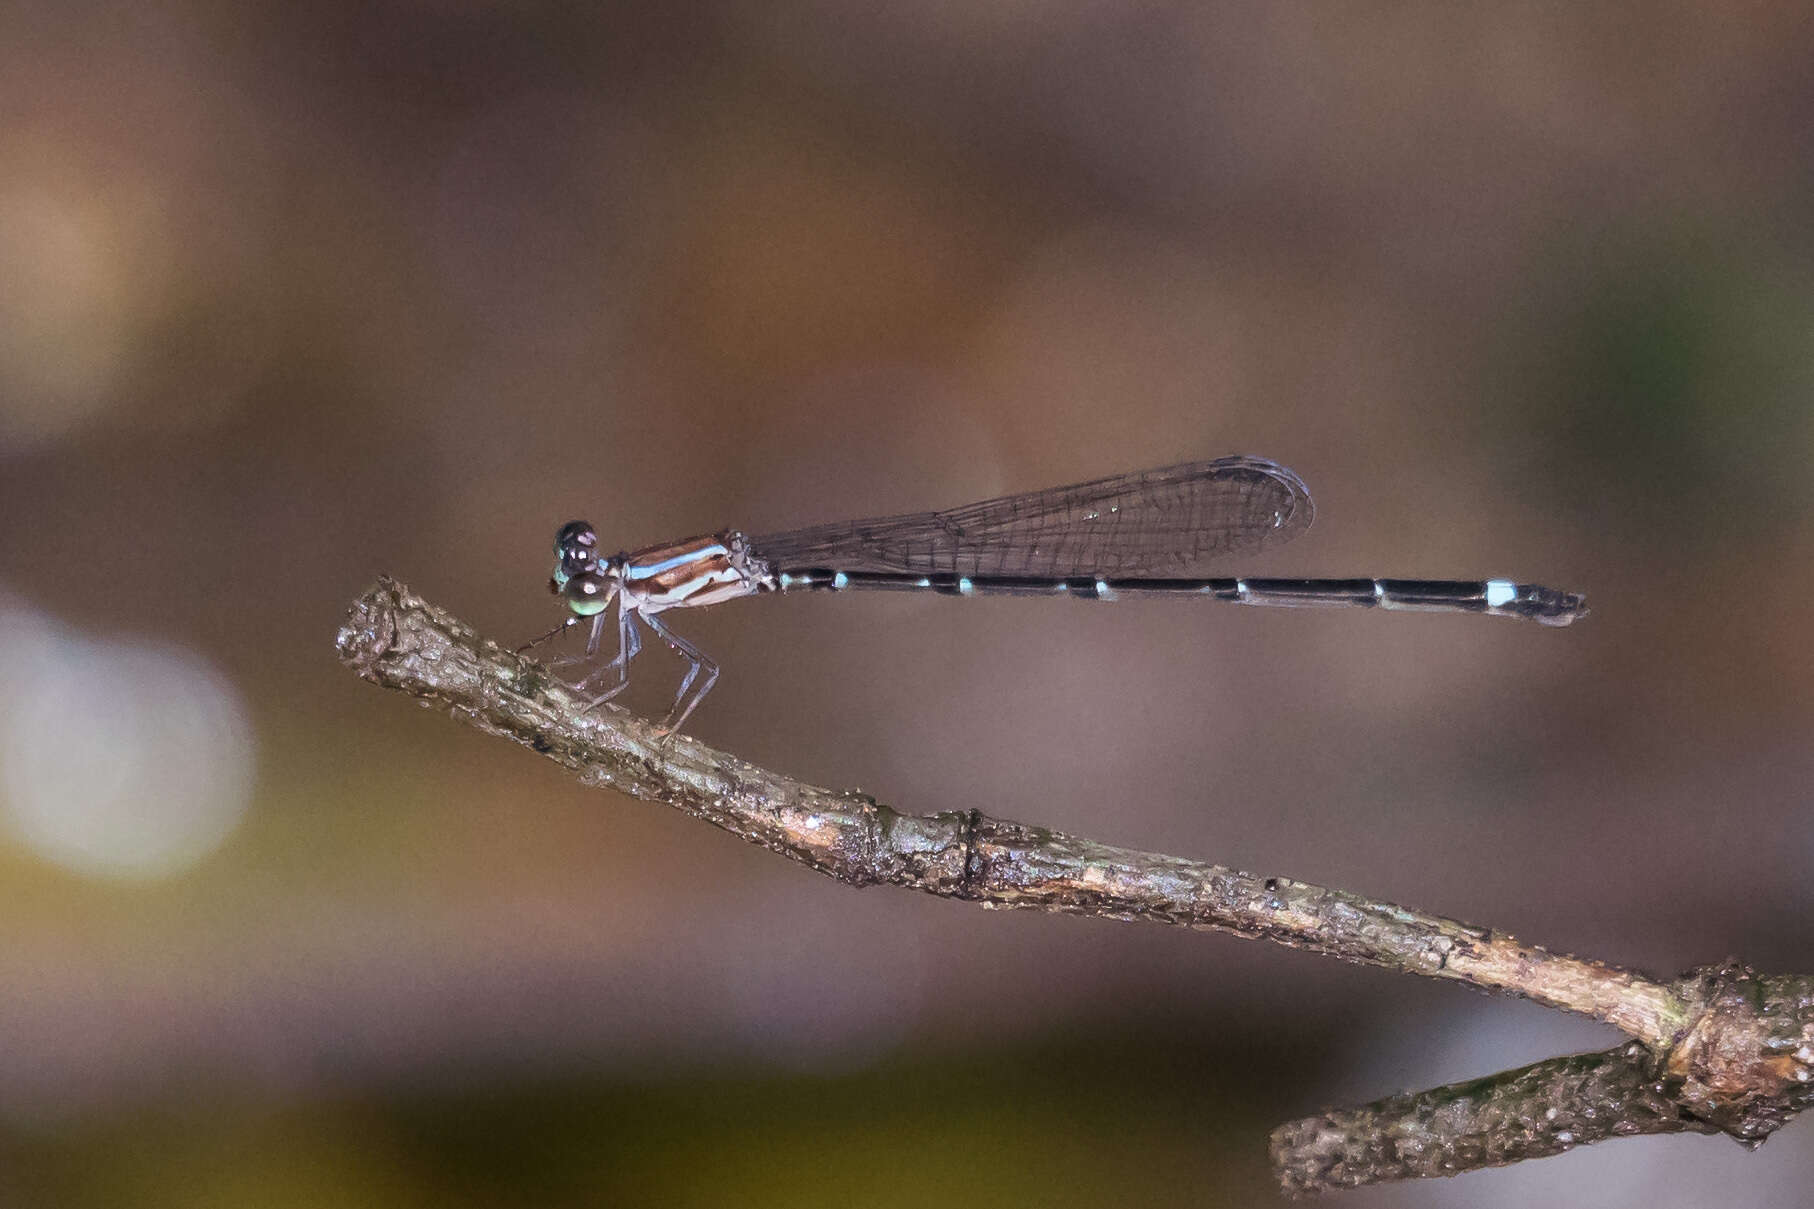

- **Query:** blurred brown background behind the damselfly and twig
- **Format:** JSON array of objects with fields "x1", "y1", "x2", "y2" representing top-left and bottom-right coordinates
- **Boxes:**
[{"x1": 0, "y1": 0, "x2": 1814, "y2": 1209}]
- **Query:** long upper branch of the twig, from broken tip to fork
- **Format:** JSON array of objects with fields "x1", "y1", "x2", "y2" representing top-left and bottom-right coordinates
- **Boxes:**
[{"x1": 339, "y1": 583, "x2": 1689, "y2": 1044}]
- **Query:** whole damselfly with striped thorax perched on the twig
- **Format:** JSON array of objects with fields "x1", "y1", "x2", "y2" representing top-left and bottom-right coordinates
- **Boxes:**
[{"x1": 532, "y1": 457, "x2": 1587, "y2": 730}]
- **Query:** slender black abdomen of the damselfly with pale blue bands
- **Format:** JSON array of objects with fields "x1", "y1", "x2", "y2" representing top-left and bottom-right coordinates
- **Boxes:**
[{"x1": 776, "y1": 566, "x2": 1575, "y2": 621}]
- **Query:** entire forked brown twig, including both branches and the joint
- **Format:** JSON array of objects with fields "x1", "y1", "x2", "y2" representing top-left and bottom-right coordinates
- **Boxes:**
[{"x1": 337, "y1": 579, "x2": 1814, "y2": 1193}]
